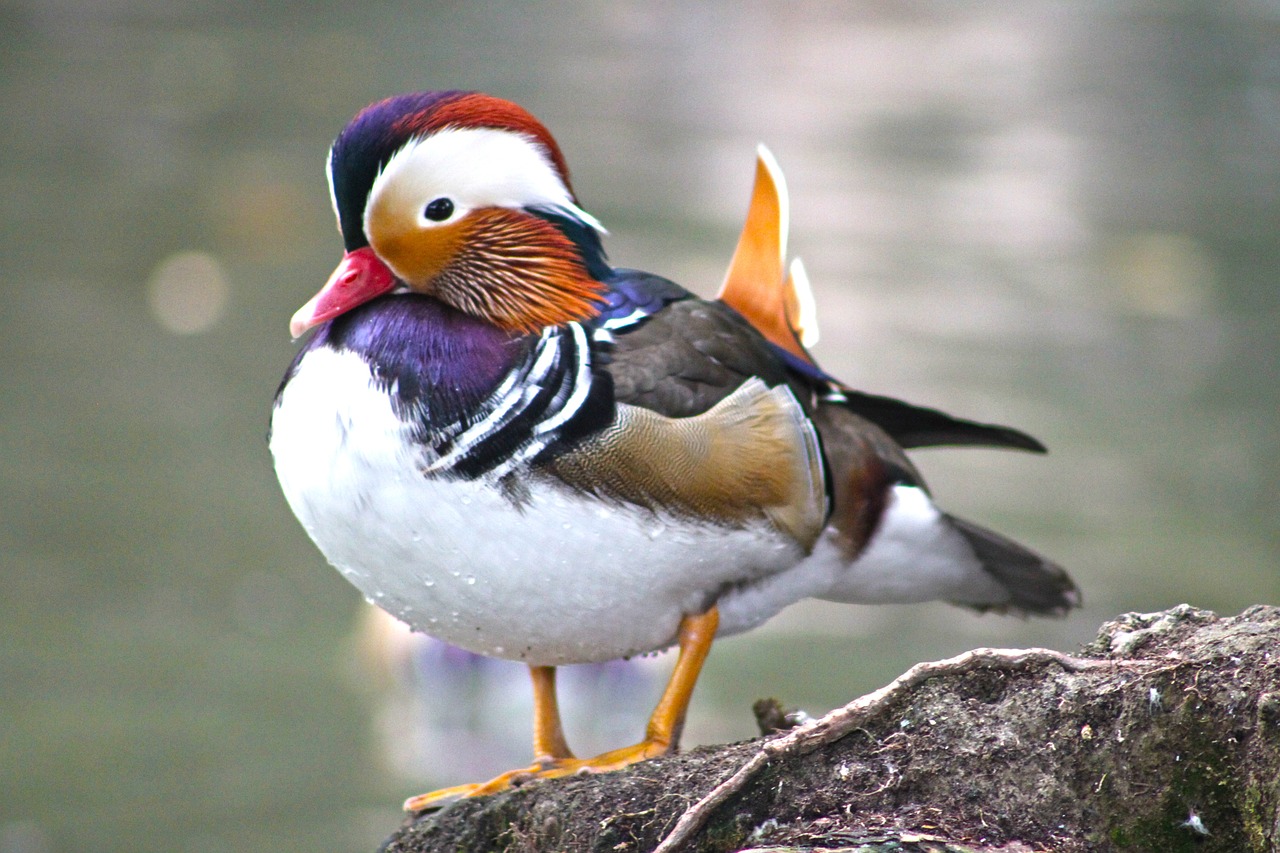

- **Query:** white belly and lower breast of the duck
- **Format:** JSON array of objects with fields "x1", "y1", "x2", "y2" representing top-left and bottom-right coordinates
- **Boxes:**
[{"x1": 271, "y1": 350, "x2": 812, "y2": 665}]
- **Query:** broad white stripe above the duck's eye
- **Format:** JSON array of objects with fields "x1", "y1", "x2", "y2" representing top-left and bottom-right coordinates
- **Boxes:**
[{"x1": 366, "y1": 128, "x2": 599, "y2": 233}]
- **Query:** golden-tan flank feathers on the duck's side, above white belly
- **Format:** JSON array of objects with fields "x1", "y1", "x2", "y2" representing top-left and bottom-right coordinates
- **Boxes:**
[{"x1": 545, "y1": 379, "x2": 826, "y2": 551}]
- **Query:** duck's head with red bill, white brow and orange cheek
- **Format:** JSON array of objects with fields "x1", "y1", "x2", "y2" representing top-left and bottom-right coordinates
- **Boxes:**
[{"x1": 289, "y1": 92, "x2": 608, "y2": 337}]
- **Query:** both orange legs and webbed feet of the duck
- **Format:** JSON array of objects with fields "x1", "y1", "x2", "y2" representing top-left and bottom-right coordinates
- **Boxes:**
[{"x1": 404, "y1": 607, "x2": 719, "y2": 812}]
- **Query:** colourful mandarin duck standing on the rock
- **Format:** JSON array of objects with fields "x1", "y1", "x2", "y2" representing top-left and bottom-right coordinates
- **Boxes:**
[{"x1": 268, "y1": 90, "x2": 1079, "y2": 812}]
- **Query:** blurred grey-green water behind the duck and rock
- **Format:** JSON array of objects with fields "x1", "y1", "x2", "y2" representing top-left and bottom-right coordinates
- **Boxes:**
[{"x1": 0, "y1": 0, "x2": 1280, "y2": 853}]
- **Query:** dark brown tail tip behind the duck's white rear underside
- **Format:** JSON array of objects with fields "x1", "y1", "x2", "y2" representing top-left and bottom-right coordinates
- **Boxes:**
[{"x1": 945, "y1": 515, "x2": 1080, "y2": 616}]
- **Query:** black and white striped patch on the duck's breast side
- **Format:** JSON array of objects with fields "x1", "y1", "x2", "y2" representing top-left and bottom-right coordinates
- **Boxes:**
[{"x1": 417, "y1": 323, "x2": 613, "y2": 479}]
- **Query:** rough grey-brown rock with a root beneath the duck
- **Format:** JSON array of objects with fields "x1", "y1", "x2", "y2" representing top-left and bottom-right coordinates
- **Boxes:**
[{"x1": 384, "y1": 605, "x2": 1280, "y2": 853}]
